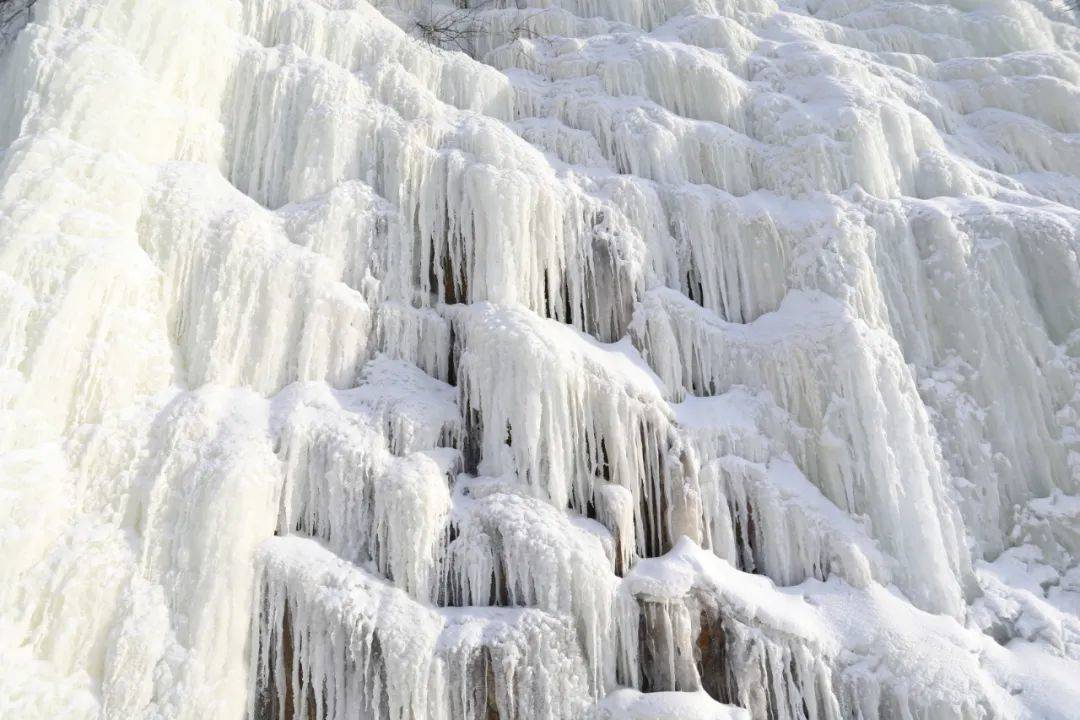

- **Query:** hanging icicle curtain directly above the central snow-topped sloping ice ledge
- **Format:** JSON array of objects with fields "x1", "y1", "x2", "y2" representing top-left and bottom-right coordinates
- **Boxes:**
[{"x1": 408, "y1": 138, "x2": 644, "y2": 339}]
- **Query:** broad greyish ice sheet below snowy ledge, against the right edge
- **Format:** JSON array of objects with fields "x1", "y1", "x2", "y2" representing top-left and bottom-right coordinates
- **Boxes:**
[{"x1": 862, "y1": 198, "x2": 1080, "y2": 554}]
